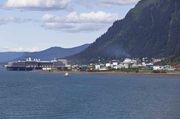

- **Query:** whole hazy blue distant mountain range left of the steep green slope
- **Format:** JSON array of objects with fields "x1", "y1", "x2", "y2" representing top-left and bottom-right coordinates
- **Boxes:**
[{"x1": 0, "y1": 44, "x2": 89, "y2": 63}]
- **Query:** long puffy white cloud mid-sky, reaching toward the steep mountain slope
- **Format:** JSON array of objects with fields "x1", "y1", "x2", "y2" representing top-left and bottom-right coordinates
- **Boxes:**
[{"x1": 42, "y1": 11, "x2": 119, "y2": 32}]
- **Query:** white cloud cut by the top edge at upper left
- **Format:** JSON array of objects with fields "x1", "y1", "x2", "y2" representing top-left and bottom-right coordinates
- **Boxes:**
[{"x1": 4, "y1": 0, "x2": 70, "y2": 10}]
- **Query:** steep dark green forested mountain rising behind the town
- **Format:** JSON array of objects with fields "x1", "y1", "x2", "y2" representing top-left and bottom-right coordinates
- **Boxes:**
[{"x1": 69, "y1": 0, "x2": 180, "y2": 63}]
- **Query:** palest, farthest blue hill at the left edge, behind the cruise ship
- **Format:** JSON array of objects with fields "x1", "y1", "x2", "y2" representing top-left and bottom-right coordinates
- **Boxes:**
[{"x1": 0, "y1": 52, "x2": 25, "y2": 63}]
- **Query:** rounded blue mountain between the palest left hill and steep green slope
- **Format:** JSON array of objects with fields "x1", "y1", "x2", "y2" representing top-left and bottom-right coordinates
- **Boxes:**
[{"x1": 20, "y1": 44, "x2": 89, "y2": 60}]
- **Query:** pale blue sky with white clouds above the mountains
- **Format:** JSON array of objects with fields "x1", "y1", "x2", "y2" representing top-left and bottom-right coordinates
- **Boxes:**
[{"x1": 0, "y1": 0, "x2": 139, "y2": 52}]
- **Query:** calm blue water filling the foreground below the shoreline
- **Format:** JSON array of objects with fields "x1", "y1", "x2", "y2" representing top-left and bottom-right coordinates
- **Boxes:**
[{"x1": 0, "y1": 71, "x2": 180, "y2": 119}]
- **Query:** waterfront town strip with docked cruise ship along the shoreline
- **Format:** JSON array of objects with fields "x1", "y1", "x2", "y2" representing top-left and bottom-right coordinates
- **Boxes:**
[{"x1": 6, "y1": 58, "x2": 180, "y2": 72}]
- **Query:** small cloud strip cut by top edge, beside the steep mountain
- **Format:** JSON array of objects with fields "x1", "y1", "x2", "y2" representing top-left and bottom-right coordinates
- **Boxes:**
[{"x1": 100, "y1": 0, "x2": 140, "y2": 5}]
